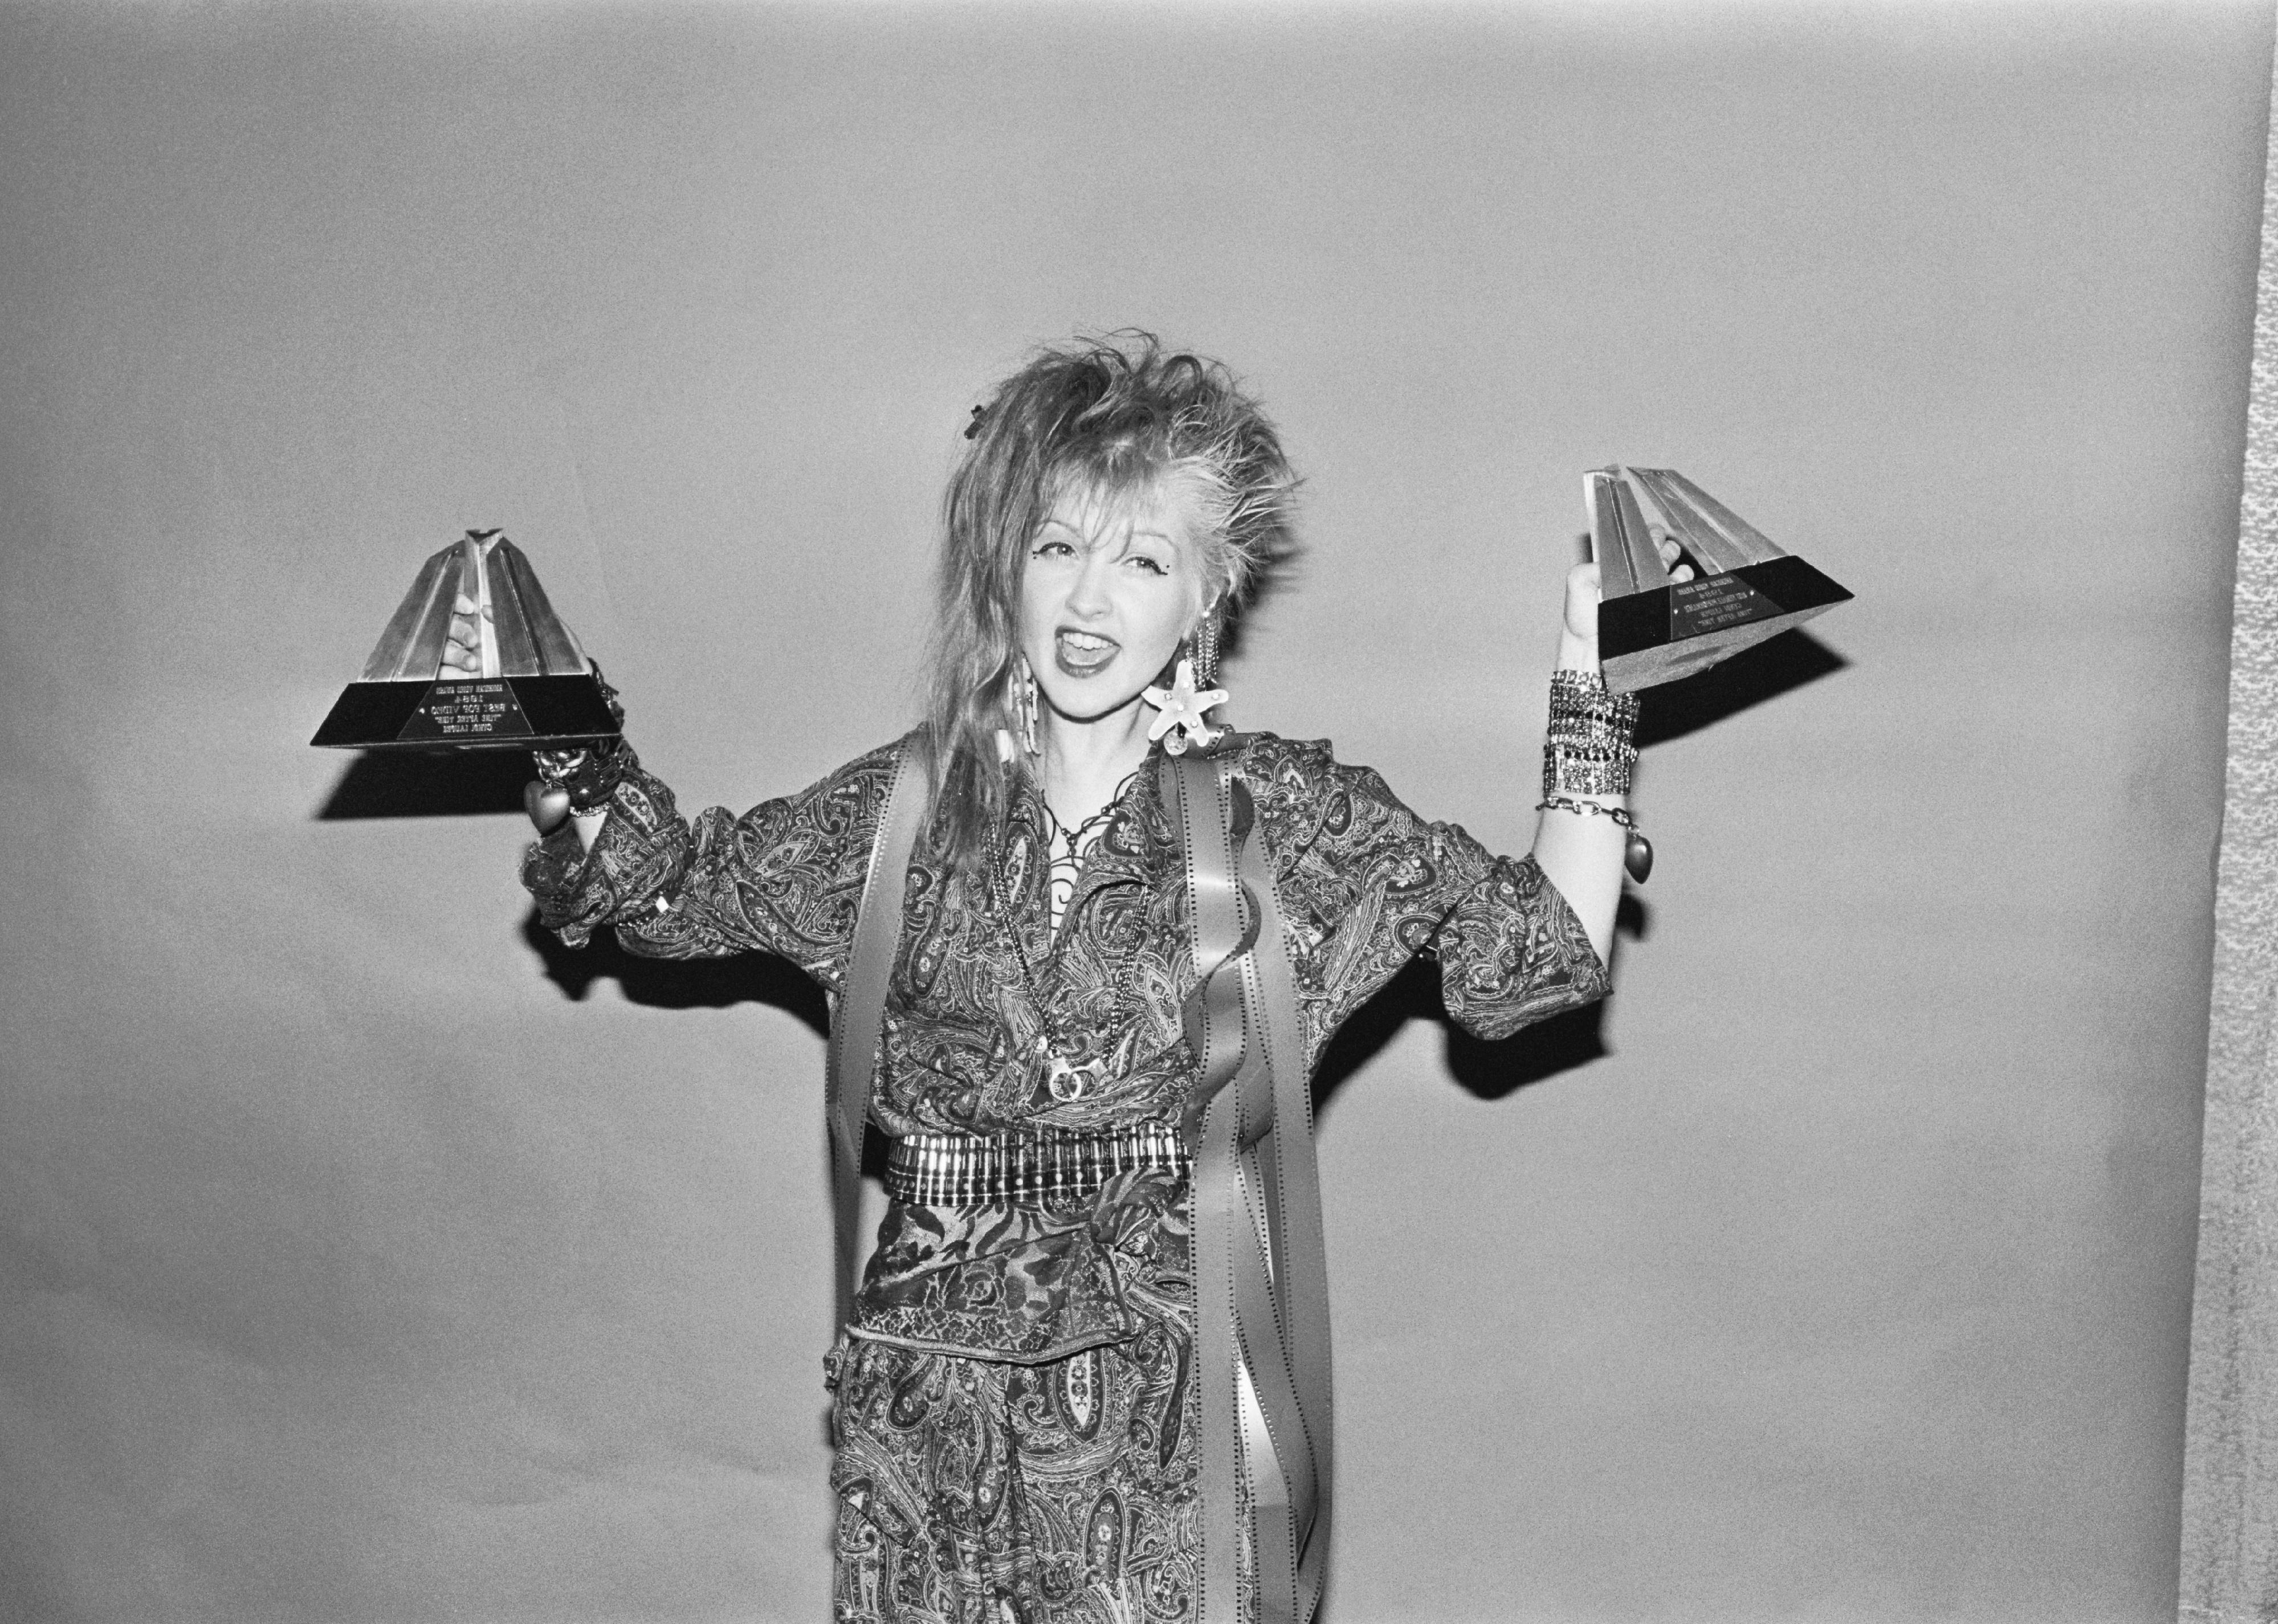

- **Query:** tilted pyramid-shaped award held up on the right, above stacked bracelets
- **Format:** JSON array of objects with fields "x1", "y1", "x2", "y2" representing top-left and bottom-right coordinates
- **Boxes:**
[{"x1": 1583, "y1": 467, "x2": 1852, "y2": 692}]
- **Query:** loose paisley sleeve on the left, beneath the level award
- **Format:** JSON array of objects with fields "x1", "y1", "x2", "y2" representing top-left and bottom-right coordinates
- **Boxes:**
[{"x1": 521, "y1": 745, "x2": 895, "y2": 991}]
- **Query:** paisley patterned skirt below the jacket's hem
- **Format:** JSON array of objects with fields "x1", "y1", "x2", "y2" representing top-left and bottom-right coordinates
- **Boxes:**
[{"x1": 832, "y1": 1314, "x2": 1248, "y2": 1624}]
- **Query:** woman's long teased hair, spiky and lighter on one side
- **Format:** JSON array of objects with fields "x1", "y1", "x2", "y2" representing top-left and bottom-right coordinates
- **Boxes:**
[{"x1": 925, "y1": 330, "x2": 1296, "y2": 868}]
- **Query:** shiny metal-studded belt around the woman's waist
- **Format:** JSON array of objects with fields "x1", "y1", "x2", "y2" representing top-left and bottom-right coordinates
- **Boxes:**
[{"x1": 886, "y1": 1123, "x2": 1193, "y2": 1207}]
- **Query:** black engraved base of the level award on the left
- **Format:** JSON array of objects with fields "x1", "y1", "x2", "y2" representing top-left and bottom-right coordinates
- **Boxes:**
[{"x1": 308, "y1": 676, "x2": 622, "y2": 749}]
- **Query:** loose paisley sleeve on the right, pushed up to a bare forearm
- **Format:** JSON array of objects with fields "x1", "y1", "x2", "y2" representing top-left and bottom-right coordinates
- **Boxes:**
[{"x1": 1246, "y1": 740, "x2": 1611, "y2": 1048}]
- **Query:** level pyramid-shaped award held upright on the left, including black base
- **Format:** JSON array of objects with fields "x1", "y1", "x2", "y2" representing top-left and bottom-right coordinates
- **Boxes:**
[{"x1": 308, "y1": 531, "x2": 620, "y2": 749}]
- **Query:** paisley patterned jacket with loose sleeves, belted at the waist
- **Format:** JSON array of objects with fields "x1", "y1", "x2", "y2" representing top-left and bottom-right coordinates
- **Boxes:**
[{"x1": 524, "y1": 733, "x2": 1608, "y2": 1362}]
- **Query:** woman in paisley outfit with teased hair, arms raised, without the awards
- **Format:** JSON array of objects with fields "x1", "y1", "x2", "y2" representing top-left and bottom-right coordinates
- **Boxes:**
[{"x1": 494, "y1": 335, "x2": 1636, "y2": 1624}]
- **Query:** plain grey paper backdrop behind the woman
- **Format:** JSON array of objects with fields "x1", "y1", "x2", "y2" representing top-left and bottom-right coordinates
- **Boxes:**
[{"x1": 0, "y1": 2, "x2": 2271, "y2": 1622}]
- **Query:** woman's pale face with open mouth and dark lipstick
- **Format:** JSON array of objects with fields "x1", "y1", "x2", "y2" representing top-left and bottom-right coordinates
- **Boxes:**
[{"x1": 1021, "y1": 485, "x2": 1203, "y2": 722}]
